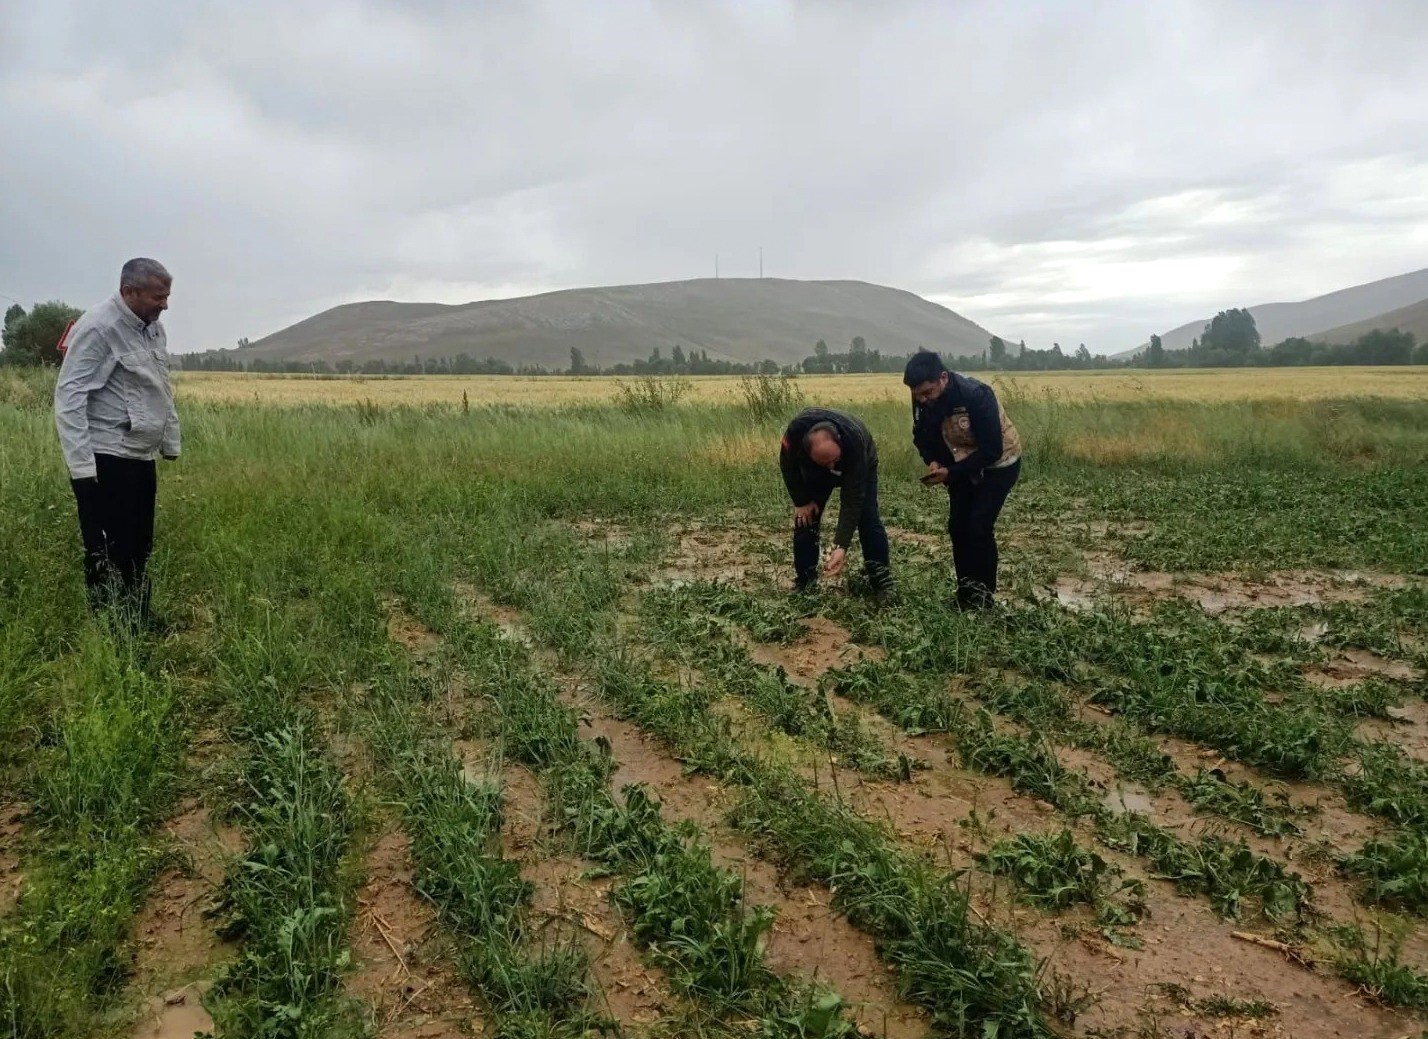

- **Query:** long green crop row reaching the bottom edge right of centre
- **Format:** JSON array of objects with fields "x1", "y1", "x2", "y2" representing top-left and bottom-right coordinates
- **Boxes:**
[{"x1": 439, "y1": 568, "x2": 1070, "y2": 1036}]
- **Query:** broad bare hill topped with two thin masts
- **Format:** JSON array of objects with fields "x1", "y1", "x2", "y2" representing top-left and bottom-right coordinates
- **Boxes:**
[{"x1": 241, "y1": 278, "x2": 991, "y2": 368}]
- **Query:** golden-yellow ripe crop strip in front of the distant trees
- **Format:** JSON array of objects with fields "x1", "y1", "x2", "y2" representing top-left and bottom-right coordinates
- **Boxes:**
[{"x1": 177, "y1": 367, "x2": 1428, "y2": 405}]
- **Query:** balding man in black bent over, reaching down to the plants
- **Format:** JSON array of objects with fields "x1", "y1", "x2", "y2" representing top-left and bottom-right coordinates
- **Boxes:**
[{"x1": 778, "y1": 408, "x2": 893, "y2": 595}]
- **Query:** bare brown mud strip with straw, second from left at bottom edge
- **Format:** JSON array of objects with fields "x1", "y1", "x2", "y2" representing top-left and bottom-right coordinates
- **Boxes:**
[{"x1": 347, "y1": 831, "x2": 473, "y2": 1039}]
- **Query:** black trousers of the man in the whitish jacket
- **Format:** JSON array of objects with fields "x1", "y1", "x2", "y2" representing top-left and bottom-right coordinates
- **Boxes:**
[{"x1": 70, "y1": 454, "x2": 159, "y2": 622}]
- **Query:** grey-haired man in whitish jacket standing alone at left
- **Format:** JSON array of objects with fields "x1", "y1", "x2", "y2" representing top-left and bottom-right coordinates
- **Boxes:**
[{"x1": 54, "y1": 258, "x2": 179, "y2": 625}]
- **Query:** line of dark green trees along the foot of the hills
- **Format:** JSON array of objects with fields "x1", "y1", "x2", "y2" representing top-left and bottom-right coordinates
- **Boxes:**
[{"x1": 0, "y1": 300, "x2": 1428, "y2": 375}]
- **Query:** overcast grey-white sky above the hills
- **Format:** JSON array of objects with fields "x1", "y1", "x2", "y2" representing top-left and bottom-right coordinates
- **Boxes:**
[{"x1": 0, "y1": 0, "x2": 1428, "y2": 353}]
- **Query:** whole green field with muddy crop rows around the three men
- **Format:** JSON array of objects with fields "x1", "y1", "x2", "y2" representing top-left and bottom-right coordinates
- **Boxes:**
[{"x1": 0, "y1": 371, "x2": 1428, "y2": 1039}]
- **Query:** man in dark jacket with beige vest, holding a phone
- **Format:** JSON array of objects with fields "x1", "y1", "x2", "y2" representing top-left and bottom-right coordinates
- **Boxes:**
[{"x1": 902, "y1": 350, "x2": 1021, "y2": 609}]
